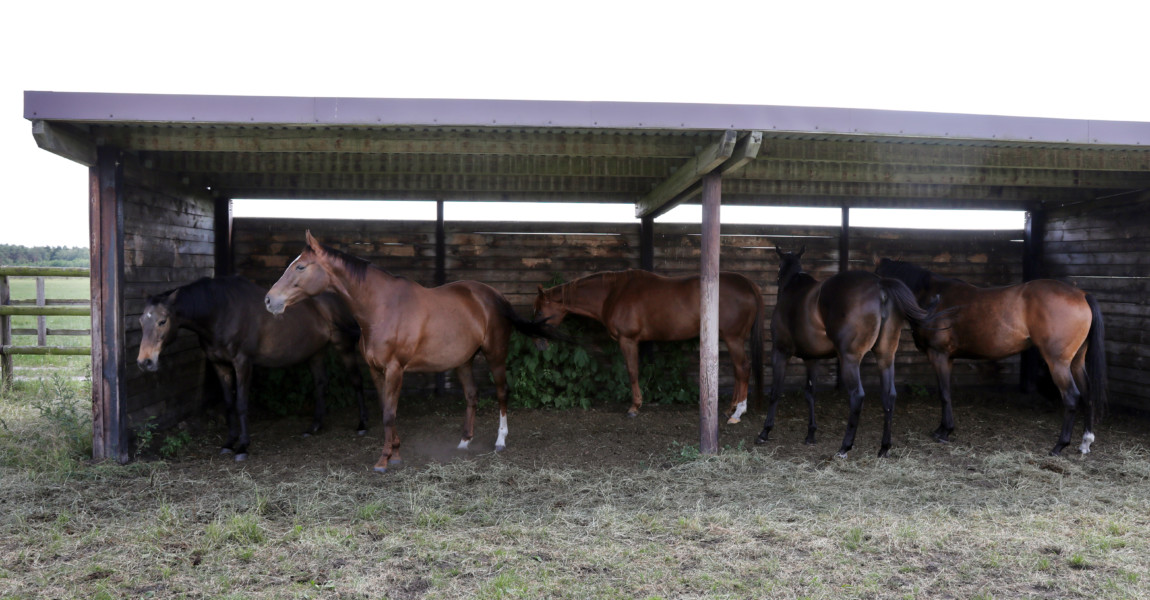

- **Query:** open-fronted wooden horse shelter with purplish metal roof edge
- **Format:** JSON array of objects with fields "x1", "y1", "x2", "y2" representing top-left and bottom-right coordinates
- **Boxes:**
[{"x1": 24, "y1": 92, "x2": 1150, "y2": 462}]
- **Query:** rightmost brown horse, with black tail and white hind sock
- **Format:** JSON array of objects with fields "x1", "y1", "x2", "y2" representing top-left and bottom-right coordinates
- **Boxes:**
[{"x1": 877, "y1": 259, "x2": 1106, "y2": 456}]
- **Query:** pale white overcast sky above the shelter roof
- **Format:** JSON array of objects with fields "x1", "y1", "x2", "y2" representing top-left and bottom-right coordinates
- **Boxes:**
[{"x1": 0, "y1": 0, "x2": 1150, "y2": 246}]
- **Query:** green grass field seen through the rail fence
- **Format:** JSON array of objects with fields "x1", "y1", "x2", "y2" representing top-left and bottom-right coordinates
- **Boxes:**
[{"x1": 1, "y1": 277, "x2": 92, "y2": 379}]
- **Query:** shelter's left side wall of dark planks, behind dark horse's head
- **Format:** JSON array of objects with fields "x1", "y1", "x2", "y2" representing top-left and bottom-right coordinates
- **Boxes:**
[{"x1": 123, "y1": 161, "x2": 215, "y2": 430}]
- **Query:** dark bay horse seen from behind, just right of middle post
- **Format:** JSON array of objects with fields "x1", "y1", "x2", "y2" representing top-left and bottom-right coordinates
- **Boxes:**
[{"x1": 754, "y1": 246, "x2": 935, "y2": 459}]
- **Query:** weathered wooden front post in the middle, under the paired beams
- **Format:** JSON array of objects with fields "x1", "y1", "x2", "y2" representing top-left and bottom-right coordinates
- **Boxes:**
[{"x1": 699, "y1": 172, "x2": 722, "y2": 454}]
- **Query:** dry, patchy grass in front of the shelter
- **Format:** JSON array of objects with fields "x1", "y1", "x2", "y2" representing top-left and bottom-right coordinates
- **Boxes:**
[{"x1": 0, "y1": 381, "x2": 1150, "y2": 599}]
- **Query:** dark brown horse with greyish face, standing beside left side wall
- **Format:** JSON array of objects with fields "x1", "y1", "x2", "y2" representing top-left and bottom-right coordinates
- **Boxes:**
[{"x1": 136, "y1": 276, "x2": 367, "y2": 461}]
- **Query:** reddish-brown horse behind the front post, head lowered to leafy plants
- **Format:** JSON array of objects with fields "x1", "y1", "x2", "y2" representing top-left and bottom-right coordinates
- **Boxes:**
[{"x1": 535, "y1": 269, "x2": 762, "y2": 423}]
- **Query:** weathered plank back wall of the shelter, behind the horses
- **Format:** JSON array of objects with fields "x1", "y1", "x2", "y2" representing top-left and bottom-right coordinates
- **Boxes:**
[{"x1": 233, "y1": 218, "x2": 1022, "y2": 397}]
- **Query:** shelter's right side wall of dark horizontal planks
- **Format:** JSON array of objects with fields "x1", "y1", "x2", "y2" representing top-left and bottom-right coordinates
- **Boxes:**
[{"x1": 1042, "y1": 192, "x2": 1150, "y2": 411}]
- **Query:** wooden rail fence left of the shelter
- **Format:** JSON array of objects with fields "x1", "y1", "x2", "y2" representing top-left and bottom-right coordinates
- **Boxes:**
[{"x1": 0, "y1": 267, "x2": 92, "y2": 385}]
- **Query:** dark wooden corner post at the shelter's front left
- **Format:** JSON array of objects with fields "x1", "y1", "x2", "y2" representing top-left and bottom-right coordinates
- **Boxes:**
[{"x1": 89, "y1": 146, "x2": 129, "y2": 463}]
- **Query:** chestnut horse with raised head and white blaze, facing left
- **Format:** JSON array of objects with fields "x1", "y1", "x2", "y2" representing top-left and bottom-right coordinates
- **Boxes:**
[{"x1": 265, "y1": 231, "x2": 561, "y2": 472}]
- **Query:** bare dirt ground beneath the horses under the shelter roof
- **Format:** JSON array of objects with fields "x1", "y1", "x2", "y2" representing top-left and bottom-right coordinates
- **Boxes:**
[{"x1": 164, "y1": 389, "x2": 1150, "y2": 477}]
